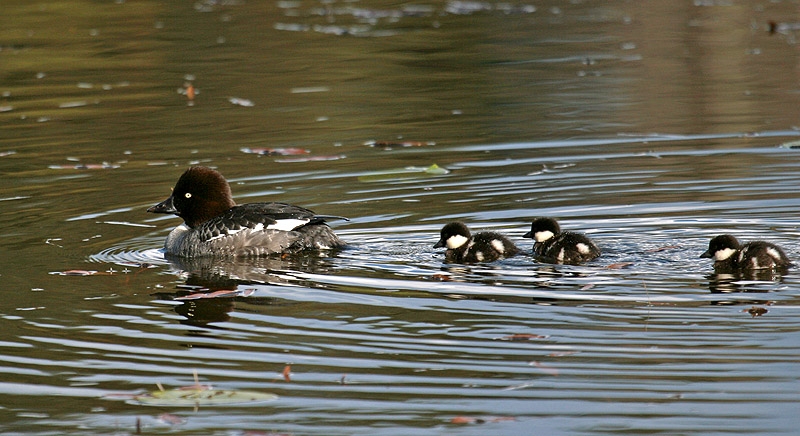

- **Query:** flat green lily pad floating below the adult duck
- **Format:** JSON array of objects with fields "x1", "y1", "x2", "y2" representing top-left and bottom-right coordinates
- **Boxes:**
[{"x1": 133, "y1": 389, "x2": 278, "y2": 407}]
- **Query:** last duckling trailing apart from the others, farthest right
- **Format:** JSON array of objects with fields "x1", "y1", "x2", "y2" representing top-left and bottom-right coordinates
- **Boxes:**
[{"x1": 700, "y1": 235, "x2": 792, "y2": 271}]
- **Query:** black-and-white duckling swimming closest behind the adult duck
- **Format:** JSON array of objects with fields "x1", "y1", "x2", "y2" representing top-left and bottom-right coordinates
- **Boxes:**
[{"x1": 433, "y1": 222, "x2": 519, "y2": 263}]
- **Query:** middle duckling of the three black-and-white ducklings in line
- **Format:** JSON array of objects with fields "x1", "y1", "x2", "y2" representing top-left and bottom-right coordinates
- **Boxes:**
[{"x1": 522, "y1": 218, "x2": 600, "y2": 265}]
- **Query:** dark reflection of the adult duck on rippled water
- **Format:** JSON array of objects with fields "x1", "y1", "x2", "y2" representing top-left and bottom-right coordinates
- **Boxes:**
[{"x1": 156, "y1": 254, "x2": 340, "y2": 327}]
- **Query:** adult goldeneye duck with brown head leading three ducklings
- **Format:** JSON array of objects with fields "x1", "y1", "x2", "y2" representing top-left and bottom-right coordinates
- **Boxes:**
[{"x1": 147, "y1": 166, "x2": 346, "y2": 257}]
